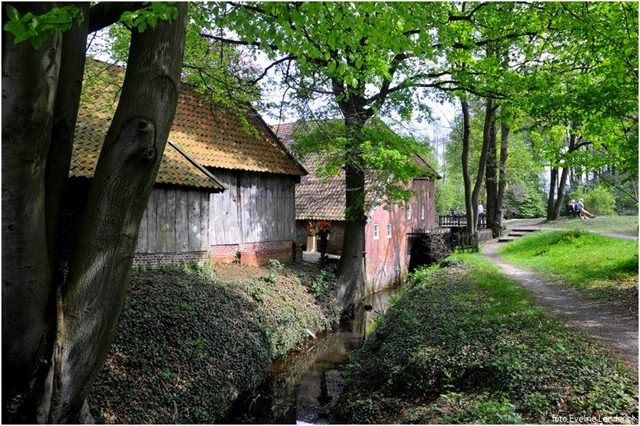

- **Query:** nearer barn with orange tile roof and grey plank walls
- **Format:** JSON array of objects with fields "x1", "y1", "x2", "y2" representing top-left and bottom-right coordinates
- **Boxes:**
[{"x1": 70, "y1": 62, "x2": 306, "y2": 264}]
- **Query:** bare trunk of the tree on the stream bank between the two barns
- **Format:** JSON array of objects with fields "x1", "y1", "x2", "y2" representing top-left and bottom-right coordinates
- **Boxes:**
[{"x1": 338, "y1": 112, "x2": 367, "y2": 315}]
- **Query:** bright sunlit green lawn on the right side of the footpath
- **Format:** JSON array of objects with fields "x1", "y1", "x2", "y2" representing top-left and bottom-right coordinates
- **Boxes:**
[{"x1": 499, "y1": 231, "x2": 638, "y2": 312}]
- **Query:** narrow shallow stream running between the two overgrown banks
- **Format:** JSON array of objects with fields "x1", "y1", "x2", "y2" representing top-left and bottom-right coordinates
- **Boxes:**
[{"x1": 225, "y1": 289, "x2": 398, "y2": 424}]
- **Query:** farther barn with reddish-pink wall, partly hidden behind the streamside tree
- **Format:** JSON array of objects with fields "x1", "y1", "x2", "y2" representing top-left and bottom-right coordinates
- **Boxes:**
[{"x1": 274, "y1": 123, "x2": 440, "y2": 293}]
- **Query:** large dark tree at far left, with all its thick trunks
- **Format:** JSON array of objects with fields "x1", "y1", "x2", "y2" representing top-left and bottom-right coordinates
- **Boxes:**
[{"x1": 2, "y1": 3, "x2": 186, "y2": 423}]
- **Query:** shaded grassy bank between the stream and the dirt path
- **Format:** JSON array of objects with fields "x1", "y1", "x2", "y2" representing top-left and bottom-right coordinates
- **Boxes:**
[{"x1": 337, "y1": 254, "x2": 637, "y2": 424}]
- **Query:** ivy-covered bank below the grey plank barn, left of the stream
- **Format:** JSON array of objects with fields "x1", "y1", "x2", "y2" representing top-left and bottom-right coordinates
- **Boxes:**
[{"x1": 90, "y1": 262, "x2": 336, "y2": 423}]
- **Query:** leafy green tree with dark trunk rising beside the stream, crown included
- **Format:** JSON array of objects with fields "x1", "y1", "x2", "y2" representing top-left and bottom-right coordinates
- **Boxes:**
[{"x1": 208, "y1": 3, "x2": 556, "y2": 310}]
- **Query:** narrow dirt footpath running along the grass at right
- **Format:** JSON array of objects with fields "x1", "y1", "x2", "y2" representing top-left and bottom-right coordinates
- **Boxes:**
[{"x1": 482, "y1": 240, "x2": 638, "y2": 371}]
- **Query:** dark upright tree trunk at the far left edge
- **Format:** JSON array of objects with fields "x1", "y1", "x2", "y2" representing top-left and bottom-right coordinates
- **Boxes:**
[{"x1": 2, "y1": 3, "x2": 62, "y2": 422}]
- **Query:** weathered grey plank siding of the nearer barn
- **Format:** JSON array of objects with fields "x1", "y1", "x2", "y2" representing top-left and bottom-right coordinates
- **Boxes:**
[{"x1": 137, "y1": 170, "x2": 295, "y2": 253}]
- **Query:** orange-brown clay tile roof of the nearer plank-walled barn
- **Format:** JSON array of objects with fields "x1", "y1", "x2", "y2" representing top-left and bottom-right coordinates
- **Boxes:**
[{"x1": 70, "y1": 61, "x2": 306, "y2": 190}]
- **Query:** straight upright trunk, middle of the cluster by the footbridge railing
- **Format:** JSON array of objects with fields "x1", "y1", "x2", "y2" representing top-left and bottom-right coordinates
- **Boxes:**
[{"x1": 482, "y1": 99, "x2": 498, "y2": 233}]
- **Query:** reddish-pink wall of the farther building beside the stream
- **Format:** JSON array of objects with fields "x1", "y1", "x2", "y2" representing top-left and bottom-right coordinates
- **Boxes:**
[{"x1": 365, "y1": 179, "x2": 436, "y2": 294}]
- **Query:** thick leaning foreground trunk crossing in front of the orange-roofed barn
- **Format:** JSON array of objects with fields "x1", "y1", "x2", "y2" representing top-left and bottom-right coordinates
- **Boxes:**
[{"x1": 47, "y1": 3, "x2": 186, "y2": 423}]
